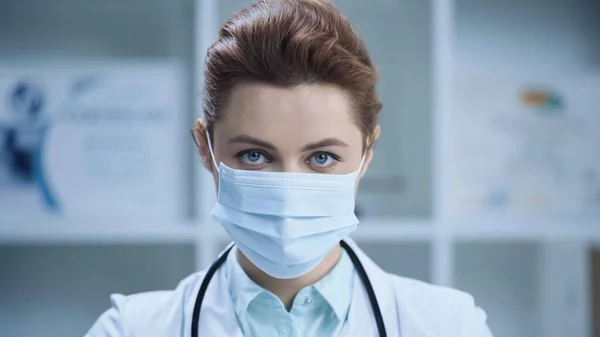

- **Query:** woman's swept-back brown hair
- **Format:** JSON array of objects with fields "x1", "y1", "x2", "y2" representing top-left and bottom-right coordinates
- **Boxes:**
[{"x1": 195, "y1": 0, "x2": 382, "y2": 144}]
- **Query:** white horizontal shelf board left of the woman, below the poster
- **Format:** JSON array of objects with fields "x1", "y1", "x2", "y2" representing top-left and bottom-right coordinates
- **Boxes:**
[{"x1": 0, "y1": 221, "x2": 200, "y2": 245}]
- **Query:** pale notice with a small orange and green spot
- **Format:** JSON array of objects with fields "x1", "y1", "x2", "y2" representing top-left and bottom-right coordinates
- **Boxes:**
[{"x1": 445, "y1": 73, "x2": 600, "y2": 219}]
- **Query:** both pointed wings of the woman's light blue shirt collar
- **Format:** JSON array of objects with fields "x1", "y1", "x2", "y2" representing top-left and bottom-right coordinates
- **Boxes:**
[{"x1": 225, "y1": 247, "x2": 354, "y2": 322}]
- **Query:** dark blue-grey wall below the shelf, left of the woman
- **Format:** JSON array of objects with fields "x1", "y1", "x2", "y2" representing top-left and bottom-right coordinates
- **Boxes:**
[{"x1": 0, "y1": 245, "x2": 194, "y2": 337}]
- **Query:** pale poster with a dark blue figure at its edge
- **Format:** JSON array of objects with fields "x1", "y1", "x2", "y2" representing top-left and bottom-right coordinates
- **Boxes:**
[{"x1": 0, "y1": 63, "x2": 184, "y2": 222}]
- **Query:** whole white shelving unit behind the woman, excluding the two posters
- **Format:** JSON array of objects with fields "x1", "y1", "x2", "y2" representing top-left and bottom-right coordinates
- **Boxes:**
[{"x1": 0, "y1": 0, "x2": 600, "y2": 337}]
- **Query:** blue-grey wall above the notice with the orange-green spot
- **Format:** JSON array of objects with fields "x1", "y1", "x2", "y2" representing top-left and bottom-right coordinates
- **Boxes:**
[{"x1": 455, "y1": 0, "x2": 600, "y2": 69}]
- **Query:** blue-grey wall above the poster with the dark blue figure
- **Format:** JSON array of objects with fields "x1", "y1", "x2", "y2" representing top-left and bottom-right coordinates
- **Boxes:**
[{"x1": 0, "y1": 0, "x2": 176, "y2": 58}]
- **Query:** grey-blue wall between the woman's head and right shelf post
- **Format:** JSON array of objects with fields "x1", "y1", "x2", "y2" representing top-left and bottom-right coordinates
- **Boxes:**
[{"x1": 344, "y1": 0, "x2": 433, "y2": 217}]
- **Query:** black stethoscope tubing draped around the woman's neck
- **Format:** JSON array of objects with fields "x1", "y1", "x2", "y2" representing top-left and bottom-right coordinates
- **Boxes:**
[{"x1": 192, "y1": 241, "x2": 387, "y2": 337}]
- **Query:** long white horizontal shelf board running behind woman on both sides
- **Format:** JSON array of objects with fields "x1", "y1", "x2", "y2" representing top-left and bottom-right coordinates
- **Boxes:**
[{"x1": 0, "y1": 218, "x2": 600, "y2": 245}]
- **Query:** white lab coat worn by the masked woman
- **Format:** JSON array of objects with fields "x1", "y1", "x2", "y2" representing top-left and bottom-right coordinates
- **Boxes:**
[{"x1": 85, "y1": 240, "x2": 492, "y2": 337}]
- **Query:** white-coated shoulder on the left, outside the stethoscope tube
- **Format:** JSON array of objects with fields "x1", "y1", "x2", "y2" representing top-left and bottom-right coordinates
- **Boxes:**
[{"x1": 85, "y1": 272, "x2": 204, "y2": 337}]
